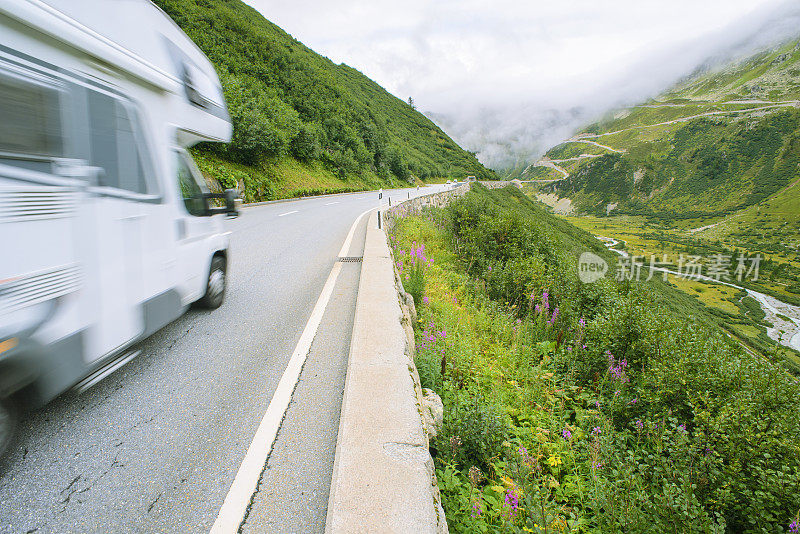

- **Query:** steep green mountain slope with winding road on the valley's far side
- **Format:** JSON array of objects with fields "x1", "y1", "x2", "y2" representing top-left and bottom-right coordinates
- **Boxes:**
[{"x1": 529, "y1": 38, "x2": 800, "y2": 226}]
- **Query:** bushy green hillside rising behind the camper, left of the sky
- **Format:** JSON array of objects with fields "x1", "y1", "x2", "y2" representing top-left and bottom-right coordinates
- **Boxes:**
[{"x1": 155, "y1": 0, "x2": 495, "y2": 200}]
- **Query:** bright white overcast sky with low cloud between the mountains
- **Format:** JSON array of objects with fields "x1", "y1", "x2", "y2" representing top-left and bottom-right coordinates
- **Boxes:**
[{"x1": 245, "y1": 0, "x2": 800, "y2": 171}]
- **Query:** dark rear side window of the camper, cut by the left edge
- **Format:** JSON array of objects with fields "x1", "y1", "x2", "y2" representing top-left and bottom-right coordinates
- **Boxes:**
[{"x1": 0, "y1": 75, "x2": 63, "y2": 157}]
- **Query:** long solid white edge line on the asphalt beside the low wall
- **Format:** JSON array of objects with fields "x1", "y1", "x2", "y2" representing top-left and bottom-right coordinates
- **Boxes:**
[{"x1": 211, "y1": 208, "x2": 374, "y2": 534}]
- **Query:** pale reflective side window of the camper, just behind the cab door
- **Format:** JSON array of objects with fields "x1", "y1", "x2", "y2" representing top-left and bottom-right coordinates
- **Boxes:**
[{"x1": 88, "y1": 91, "x2": 154, "y2": 194}]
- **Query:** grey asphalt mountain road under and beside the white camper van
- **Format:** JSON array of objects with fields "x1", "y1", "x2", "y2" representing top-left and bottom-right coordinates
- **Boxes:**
[{"x1": 0, "y1": 187, "x2": 450, "y2": 533}]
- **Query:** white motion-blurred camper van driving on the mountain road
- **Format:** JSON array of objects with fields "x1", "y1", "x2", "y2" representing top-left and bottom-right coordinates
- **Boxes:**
[{"x1": 0, "y1": 0, "x2": 236, "y2": 452}]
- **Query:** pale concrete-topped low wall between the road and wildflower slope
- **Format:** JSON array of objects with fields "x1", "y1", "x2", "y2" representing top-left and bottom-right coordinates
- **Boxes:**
[{"x1": 326, "y1": 213, "x2": 447, "y2": 534}]
